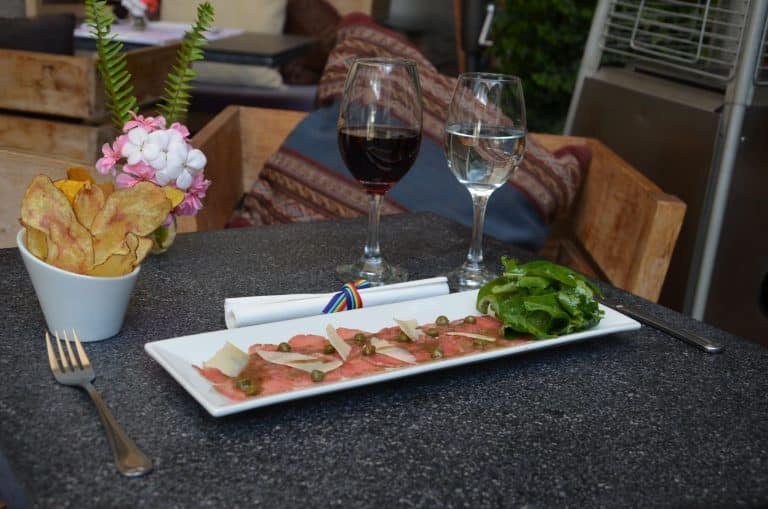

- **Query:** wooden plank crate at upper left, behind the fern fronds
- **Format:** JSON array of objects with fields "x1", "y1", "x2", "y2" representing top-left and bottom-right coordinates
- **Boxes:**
[{"x1": 0, "y1": 45, "x2": 178, "y2": 163}]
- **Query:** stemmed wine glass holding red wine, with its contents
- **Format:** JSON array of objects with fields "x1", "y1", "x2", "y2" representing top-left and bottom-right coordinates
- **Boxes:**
[{"x1": 336, "y1": 58, "x2": 422, "y2": 285}]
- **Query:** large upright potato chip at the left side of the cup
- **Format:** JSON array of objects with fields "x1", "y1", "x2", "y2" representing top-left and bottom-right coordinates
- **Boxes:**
[{"x1": 21, "y1": 175, "x2": 93, "y2": 274}]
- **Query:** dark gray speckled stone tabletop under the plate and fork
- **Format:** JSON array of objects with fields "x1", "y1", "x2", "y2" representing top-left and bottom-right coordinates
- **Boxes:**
[{"x1": 0, "y1": 214, "x2": 768, "y2": 508}]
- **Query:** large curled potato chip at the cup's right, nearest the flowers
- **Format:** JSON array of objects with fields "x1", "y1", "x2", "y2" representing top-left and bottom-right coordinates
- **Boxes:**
[{"x1": 91, "y1": 182, "x2": 171, "y2": 265}]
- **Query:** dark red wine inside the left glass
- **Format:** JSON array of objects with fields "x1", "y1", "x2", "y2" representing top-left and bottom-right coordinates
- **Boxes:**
[{"x1": 339, "y1": 126, "x2": 421, "y2": 194}]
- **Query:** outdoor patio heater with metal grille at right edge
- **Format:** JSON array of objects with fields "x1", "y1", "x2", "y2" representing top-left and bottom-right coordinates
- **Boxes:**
[{"x1": 565, "y1": 0, "x2": 768, "y2": 344}]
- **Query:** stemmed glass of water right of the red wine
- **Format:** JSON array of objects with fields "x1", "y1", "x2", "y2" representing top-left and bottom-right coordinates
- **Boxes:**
[{"x1": 445, "y1": 73, "x2": 526, "y2": 291}]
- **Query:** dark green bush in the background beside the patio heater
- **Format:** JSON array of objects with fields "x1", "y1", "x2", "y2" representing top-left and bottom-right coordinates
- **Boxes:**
[{"x1": 488, "y1": 0, "x2": 596, "y2": 133}]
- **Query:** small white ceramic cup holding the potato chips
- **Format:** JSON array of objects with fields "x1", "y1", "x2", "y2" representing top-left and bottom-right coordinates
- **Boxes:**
[{"x1": 16, "y1": 229, "x2": 141, "y2": 341}]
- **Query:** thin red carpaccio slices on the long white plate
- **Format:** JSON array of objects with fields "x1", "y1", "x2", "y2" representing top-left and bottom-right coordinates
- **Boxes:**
[{"x1": 195, "y1": 316, "x2": 532, "y2": 401}]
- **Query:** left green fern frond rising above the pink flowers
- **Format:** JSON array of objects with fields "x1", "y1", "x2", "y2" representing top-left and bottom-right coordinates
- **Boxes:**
[{"x1": 85, "y1": 0, "x2": 137, "y2": 130}]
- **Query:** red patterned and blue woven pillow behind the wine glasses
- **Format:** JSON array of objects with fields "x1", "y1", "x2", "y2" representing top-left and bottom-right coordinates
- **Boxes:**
[{"x1": 230, "y1": 14, "x2": 589, "y2": 250}]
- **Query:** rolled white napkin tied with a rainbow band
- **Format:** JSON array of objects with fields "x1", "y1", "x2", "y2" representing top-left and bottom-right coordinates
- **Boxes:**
[{"x1": 224, "y1": 277, "x2": 448, "y2": 329}]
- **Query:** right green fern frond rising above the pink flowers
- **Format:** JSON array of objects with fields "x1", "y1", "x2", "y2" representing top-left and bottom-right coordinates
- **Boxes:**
[{"x1": 159, "y1": 2, "x2": 214, "y2": 123}]
